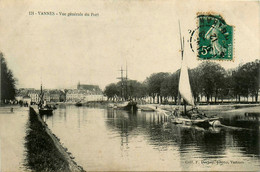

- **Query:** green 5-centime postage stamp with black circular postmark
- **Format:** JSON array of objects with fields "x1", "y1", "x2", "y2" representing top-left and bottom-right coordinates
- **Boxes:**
[{"x1": 189, "y1": 14, "x2": 234, "y2": 60}]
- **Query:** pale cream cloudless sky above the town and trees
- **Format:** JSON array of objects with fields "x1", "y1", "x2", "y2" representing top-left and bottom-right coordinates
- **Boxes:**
[{"x1": 0, "y1": 0, "x2": 260, "y2": 89}]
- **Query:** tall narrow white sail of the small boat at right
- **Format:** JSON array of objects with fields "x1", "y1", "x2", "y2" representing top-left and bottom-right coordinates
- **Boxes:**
[{"x1": 179, "y1": 53, "x2": 194, "y2": 106}]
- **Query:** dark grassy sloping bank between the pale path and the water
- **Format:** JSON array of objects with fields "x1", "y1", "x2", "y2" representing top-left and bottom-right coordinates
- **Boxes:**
[{"x1": 25, "y1": 107, "x2": 83, "y2": 171}]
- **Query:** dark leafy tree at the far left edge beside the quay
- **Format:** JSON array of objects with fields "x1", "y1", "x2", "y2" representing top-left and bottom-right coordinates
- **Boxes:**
[{"x1": 0, "y1": 52, "x2": 16, "y2": 102}]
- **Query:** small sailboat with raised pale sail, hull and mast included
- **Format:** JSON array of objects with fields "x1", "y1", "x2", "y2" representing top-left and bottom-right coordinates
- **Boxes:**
[{"x1": 171, "y1": 21, "x2": 220, "y2": 127}]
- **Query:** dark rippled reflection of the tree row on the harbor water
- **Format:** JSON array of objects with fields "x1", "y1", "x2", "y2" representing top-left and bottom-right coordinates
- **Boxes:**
[{"x1": 104, "y1": 110, "x2": 260, "y2": 169}]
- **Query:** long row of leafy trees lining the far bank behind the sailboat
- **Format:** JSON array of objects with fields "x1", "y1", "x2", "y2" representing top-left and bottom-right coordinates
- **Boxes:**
[{"x1": 104, "y1": 60, "x2": 260, "y2": 103}]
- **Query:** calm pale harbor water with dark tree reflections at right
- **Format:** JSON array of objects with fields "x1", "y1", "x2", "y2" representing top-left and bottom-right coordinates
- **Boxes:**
[{"x1": 44, "y1": 105, "x2": 260, "y2": 171}]
